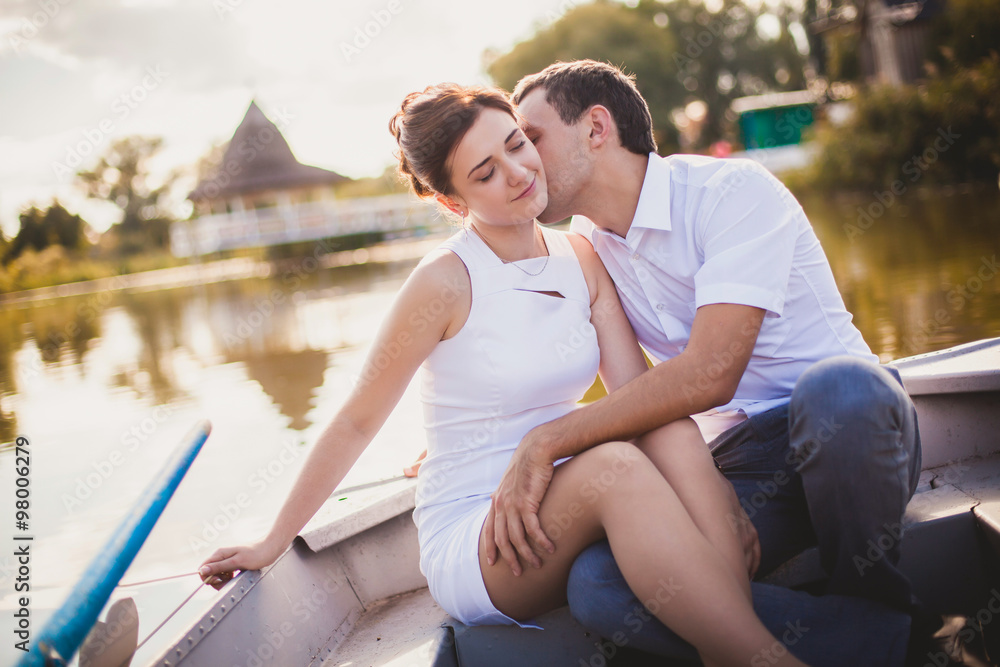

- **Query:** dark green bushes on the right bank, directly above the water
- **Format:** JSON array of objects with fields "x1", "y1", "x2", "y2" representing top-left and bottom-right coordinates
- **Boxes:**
[{"x1": 805, "y1": 57, "x2": 1000, "y2": 190}]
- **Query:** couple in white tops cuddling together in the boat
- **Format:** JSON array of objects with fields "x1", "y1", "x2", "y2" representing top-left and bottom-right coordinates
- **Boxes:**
[{"x1": 201, "y1": 61, "x2": 920, "y2": 665}]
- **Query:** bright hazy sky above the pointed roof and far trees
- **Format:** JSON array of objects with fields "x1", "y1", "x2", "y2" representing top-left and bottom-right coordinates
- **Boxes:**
[{"x1": 0, "y1": 0, "x2": 628, "y2": 236}]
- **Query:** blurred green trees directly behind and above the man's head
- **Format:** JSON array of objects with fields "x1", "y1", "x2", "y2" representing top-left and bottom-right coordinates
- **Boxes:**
[{"x1": 488, "y1": 0, "x2": 805, "y2": 153}]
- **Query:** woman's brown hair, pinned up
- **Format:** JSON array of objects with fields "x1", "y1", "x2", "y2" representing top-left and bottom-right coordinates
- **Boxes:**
[{"x1": 389, "y1": 83, "x2": 517, "y2": 198}]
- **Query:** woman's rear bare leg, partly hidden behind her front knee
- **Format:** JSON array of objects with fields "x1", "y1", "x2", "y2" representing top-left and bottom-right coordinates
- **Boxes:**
[{"x1": 636, "y1": 419, "x2": 750, "y2": 600}]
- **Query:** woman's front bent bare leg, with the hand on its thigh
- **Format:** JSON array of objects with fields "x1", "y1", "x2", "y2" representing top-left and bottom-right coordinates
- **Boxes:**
[{"x1": 479, "y1": 442, "x2": 802, "y2": 665}]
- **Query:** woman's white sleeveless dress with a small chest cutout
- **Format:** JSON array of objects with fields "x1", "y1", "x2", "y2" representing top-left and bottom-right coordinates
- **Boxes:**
[{"x1": 413, "y1": 228, "x2": 600, "y2": 627}]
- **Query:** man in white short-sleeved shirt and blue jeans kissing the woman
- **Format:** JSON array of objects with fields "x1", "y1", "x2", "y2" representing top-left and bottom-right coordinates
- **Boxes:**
[{"x1": 487, "y1": 61, "x2": 936, "y2": 665}]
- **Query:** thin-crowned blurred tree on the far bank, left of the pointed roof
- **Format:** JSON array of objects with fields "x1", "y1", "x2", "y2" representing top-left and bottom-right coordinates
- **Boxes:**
[{"x1": 77, "y1": 136, "x2": 178, "y2": 254}]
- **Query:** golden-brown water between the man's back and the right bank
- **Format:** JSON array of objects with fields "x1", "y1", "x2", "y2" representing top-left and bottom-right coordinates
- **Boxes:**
[{"x1": 802, "y1": 190, "x2": 1000, "y2": 361}]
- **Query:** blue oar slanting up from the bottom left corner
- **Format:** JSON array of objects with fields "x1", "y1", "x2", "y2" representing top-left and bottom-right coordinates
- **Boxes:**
[{"x1": 17, "y1": 421, "x2": 212, "y2": 667}]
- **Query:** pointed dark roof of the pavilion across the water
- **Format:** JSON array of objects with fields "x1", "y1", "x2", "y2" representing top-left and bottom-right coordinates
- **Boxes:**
[{"x1": 188, "y1": 101, "x2": 350, "y2": 200}]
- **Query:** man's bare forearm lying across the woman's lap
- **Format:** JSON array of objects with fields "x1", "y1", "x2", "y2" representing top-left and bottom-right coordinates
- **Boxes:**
[{"x1": 540, "y1": 354, "x2": 729, "y2": 461}]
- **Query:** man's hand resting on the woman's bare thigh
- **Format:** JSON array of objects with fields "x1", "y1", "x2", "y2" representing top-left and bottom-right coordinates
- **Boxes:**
[{"x1": 483, "y1": 444, "x2": 556, "y2": 576}]
